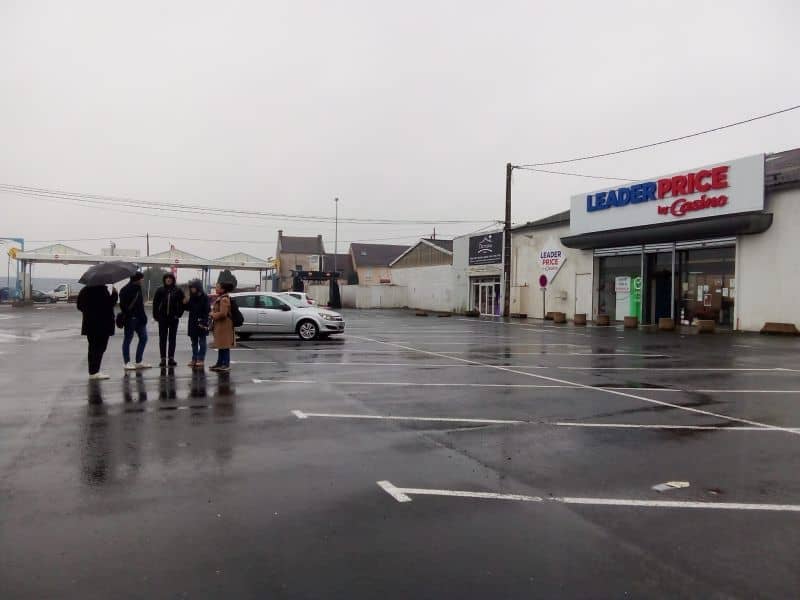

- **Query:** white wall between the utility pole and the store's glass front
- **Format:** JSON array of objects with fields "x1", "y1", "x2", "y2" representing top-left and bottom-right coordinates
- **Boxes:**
[{"x1": 511, "y1": 225, "x2": 594, "y2": 319}]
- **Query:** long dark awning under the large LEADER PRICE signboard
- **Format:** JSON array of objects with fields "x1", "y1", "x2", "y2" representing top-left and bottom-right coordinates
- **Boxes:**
[{"x1": 561, "y1": 212, "x2": 772, "y2": 250}]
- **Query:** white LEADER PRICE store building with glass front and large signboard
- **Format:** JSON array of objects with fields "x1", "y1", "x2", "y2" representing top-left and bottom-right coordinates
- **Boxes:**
[{"x1": 488, "y1": 149, "x2": 800, "y2": 331}]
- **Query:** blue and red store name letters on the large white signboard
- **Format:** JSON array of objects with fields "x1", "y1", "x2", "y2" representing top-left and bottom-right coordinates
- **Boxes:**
[{"x1": 586, "y1": 165, "x2": 730, "y2": 216}]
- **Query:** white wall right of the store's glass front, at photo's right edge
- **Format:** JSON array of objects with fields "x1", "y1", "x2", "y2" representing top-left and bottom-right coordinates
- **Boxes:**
[{"x1": 736, "y1": 188, "x2": 800, "y2": 331}]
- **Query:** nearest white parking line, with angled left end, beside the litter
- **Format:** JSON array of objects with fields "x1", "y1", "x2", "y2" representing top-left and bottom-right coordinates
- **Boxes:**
[{"x1": 376, "y1": 480, "x2": 800, "y2": 512}]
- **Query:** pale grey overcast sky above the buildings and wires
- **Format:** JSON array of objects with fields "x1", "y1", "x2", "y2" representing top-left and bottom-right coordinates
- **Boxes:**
[{"x1": 0, "y1": 0, "x2": 800, "y2": 275}]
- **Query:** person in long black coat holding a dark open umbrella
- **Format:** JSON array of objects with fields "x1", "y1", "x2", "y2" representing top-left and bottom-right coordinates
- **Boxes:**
[{"x1": 77, "y1": 261, "x2": 137, "y2": 379}]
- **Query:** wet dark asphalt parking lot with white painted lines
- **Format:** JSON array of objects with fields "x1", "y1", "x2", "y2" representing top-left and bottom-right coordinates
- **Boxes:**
[{"x1": 0, "y1": 305, "x2": 800, "y2": 599}]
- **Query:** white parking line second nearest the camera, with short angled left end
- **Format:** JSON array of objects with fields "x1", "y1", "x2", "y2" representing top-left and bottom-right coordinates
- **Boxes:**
[{"x1": 291, "y1": 410, "x2": 800, "y2": 433}]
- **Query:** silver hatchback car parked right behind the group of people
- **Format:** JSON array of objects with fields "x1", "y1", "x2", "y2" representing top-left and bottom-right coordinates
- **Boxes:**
[{"x1": 231, "y1": 292, "x2": 344, "y2": 341}]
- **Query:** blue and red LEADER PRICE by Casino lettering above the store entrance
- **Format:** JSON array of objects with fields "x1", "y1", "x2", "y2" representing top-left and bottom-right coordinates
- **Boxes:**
[{"x1": 586, "y1": 165, "x2": 730, "y2": 217}]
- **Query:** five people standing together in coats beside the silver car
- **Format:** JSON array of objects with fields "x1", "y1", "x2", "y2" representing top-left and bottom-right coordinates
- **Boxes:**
[{"x1": 78, "y1": 273, "x2": 236, "y2": 379}]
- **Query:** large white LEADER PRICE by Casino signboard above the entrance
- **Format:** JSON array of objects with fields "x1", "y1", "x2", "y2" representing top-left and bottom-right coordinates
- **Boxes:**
[{"x1": 570, "y1": 154, "x2": 764, "y2": 235}]
